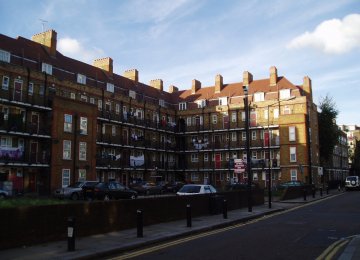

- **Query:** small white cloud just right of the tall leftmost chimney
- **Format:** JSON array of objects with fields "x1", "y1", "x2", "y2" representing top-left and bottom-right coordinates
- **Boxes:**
[{"x1": 57, "y1": 37, "x2": 104, "y2": 63}]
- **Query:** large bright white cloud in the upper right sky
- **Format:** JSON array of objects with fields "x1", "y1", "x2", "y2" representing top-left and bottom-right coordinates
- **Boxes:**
[{"x1": 287, "y1": 14, "x2": 360, "y2": 54}]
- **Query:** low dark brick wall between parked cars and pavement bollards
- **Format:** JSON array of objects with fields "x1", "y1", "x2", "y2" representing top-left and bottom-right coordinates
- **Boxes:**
[{"x1": 0, "y1": 190, "x2": 264, "y2": 250}]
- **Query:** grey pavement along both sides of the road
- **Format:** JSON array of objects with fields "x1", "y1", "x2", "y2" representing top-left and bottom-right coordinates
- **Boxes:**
[{"x1": 0, "y1": 190, "x2": 360, "y2": 260}]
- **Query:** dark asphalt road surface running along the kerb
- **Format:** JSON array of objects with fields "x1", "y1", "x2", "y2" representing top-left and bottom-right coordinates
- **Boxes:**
[{"x1": 110, "y1": 192, "x2": 360, "y2": 260}]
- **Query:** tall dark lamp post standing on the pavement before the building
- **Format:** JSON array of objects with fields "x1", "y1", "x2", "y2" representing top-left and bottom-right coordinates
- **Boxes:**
[{"x1": 243, "y1": 86, "x2": 252, "y2": 212}]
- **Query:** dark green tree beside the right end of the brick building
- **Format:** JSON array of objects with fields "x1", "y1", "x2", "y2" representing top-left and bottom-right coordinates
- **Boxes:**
[{"x1": 318, "y1": 95, "x2": 340, "y2": 163}]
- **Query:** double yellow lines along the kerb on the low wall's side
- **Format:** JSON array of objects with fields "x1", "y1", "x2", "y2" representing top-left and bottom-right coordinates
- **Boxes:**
[{"x1": 109, "y1": 194, "x2": 342, "y2": 260}]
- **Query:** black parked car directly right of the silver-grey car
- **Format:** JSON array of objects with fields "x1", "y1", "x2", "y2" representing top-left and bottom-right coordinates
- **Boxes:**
[{"x1": 84, "y1": 182, "x2": 138, "y2": 200}]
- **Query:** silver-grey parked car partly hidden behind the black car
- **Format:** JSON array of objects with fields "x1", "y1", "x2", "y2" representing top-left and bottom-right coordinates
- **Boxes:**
[{"x1": 54, "y1": 181, "x2": 99, "y2": 200}]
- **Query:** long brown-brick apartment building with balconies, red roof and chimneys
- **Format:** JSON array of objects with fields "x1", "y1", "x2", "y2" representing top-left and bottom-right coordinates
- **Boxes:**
[{"x1": 0, "y1": 30, "x2": 319, "y2": 194}]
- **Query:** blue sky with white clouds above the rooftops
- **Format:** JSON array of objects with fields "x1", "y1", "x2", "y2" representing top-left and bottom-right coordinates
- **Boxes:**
[{"x1": 0, "y1": 0, "x2": 360, "y2": 125}]
